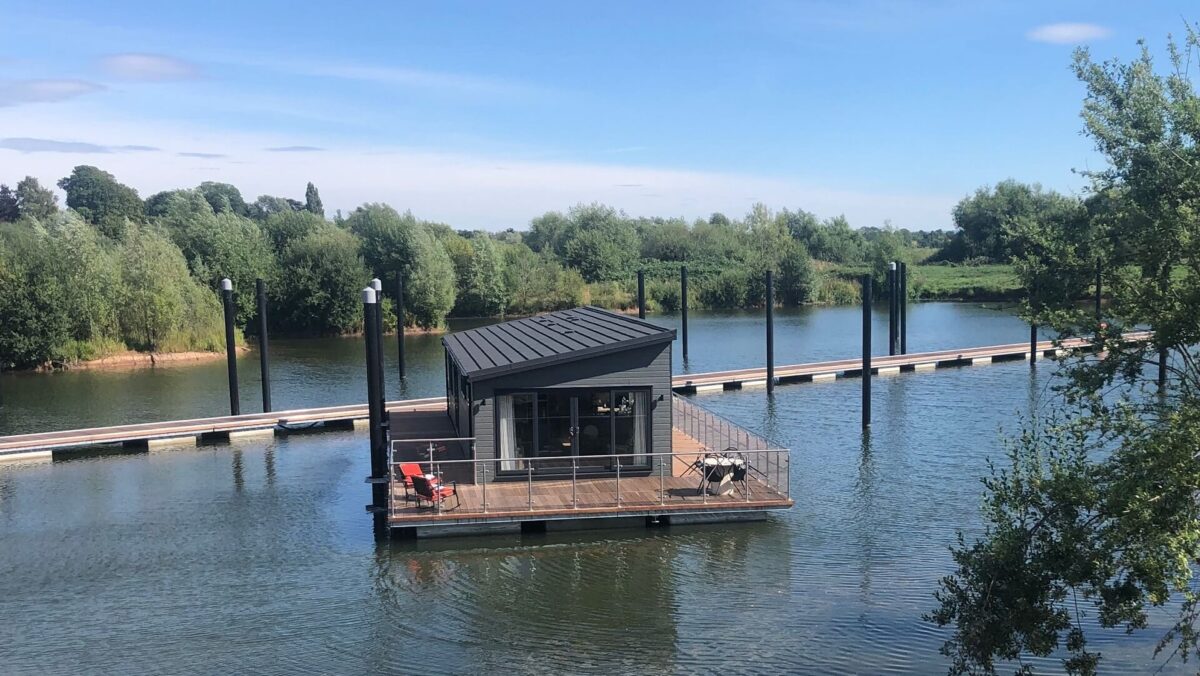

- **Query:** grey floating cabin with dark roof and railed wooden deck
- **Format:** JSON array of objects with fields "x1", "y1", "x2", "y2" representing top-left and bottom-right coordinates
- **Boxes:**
[{"x1": 388, "y1": 307, "x2": 792, "y2": 537}]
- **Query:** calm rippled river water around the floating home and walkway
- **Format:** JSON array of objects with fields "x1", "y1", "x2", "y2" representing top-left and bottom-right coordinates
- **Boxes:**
[{"x1": 0, "y1": 304, "x2": 1178, "y2": 674}]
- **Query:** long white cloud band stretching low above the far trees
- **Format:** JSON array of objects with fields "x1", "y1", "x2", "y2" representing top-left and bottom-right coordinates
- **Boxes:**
[{"x1": 0, "y1": 109, "x2": 959, "y2": 229}]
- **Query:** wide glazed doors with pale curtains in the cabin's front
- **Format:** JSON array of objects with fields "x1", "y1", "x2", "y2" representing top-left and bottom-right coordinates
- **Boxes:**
[{"x1": 496, "y1": 389, "x2": 650, "y2": 472}]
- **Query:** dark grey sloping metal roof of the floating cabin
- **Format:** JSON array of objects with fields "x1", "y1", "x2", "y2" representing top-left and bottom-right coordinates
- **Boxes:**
[{"x1": 442, "y1": 306, "x2": 674, "y2": 379}]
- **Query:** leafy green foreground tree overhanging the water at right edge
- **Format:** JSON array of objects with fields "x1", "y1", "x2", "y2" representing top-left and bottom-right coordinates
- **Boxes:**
[{"x1": 931, "y1": 26, "x2": 1200, "y2": 674}]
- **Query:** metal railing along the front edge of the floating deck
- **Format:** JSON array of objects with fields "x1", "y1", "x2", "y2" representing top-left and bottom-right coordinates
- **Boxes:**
[{"x1": 388, "y1": 439, "x2": 791, "y2": 516}]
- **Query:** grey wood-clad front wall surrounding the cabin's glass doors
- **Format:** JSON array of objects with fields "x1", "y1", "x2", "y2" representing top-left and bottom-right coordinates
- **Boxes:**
[{"x1": 463, "y1": 343, "x2": 671, "y2": 477}]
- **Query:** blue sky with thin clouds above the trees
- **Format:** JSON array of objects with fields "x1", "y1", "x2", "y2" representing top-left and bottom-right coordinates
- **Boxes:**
[{"x1": 0, "y1": 0, "x2": 1200, "y2": 229}]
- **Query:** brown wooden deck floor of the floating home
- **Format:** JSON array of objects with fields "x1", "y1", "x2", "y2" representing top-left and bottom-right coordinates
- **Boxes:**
[{"x1": 389, "y1": 429, "x2": 792, "y2": 528}]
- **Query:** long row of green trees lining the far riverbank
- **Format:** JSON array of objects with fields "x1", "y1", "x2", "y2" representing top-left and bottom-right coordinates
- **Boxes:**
[{"x1": 0, "y1": 166, "x2": 950, "y2": 366}]
